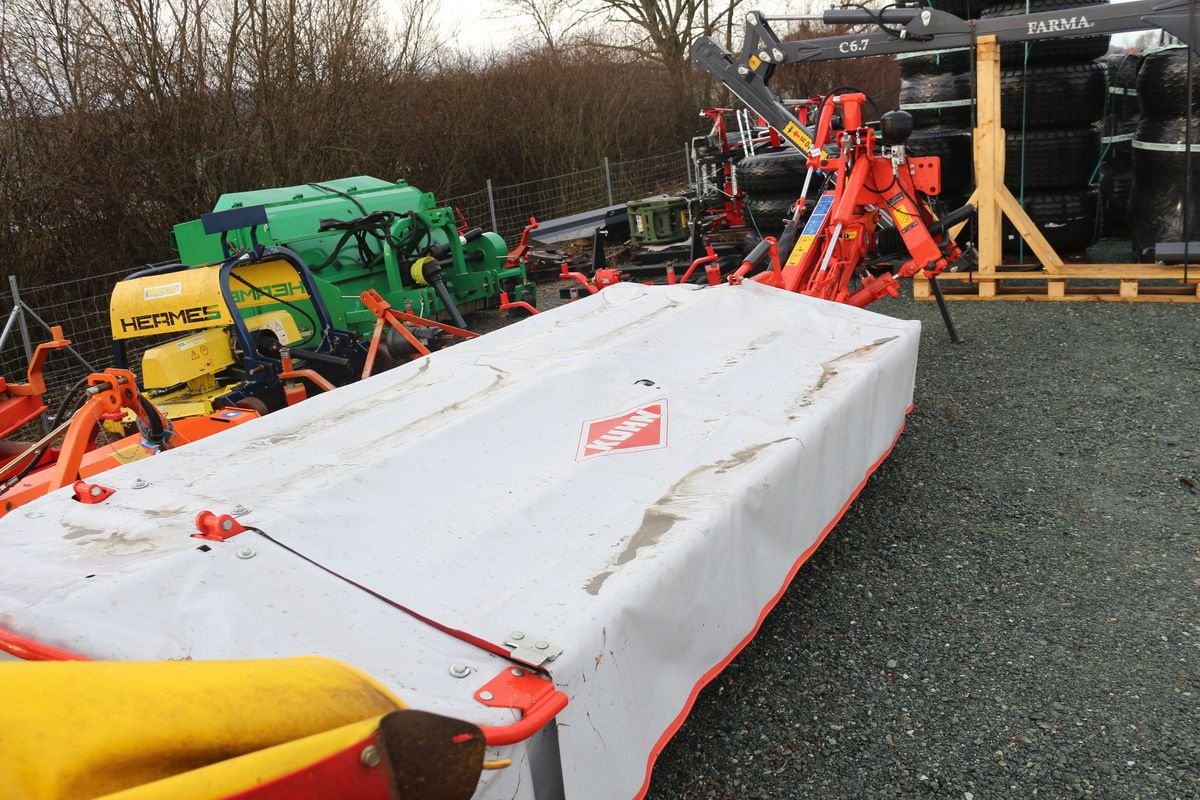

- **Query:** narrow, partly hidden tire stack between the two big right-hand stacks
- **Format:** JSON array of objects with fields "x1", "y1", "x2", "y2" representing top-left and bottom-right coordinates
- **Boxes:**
[{"x1": 1100, "y1": 53, "x2": 1141, "y2": 236}]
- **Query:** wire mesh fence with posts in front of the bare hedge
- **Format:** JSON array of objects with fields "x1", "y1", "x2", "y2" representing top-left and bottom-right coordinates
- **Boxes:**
[{"x1": 0, "y1": 148, "x2": 690, "y2": 419}]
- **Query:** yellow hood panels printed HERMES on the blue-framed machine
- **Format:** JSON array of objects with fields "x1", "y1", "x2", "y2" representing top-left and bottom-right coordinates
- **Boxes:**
[{"x1": 109, "y1": 260, "x2": 308, "y2": 339}]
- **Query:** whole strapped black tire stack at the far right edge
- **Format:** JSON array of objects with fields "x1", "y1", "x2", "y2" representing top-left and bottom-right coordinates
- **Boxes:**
[{"x1": 1129, "y1": 47, "x2": 1200, "y2": 260}]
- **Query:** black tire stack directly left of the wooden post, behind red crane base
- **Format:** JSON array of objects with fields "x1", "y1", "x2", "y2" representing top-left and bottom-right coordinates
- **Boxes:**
[{"x1": 896, "y1": 0, "x2": 984, "y2": 224}]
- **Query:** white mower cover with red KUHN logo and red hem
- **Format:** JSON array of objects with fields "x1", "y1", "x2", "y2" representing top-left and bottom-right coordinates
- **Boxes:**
[{"x1": 0, "y1": 283, "x2": 919, "y2": 800}]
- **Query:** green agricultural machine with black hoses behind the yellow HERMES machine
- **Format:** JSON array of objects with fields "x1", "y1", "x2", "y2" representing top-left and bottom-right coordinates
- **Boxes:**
[{"x1": 174, "y1": 175, "x2": 536, "y2": 336}]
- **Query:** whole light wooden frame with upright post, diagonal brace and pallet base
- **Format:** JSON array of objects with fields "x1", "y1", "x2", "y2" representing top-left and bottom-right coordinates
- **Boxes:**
[{"x1": 913, "y1": 36, "x2": 1200, "y2": 302}]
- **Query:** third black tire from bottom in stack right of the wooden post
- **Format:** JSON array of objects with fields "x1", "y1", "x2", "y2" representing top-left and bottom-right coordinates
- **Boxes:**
[{"x1": 1000, "y1": 61, "x2": 1109, "y2": 133}]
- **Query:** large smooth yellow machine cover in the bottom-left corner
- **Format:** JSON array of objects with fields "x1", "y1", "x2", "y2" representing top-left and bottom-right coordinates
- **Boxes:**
[{"x1": 0, "y1": 656, "x2": 404, "y2": 800}]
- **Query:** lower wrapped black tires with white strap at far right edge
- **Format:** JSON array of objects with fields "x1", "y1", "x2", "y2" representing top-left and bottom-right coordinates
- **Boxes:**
[{"x1": 1129, "y1": 115, "x2": 1200, "y2": 260}]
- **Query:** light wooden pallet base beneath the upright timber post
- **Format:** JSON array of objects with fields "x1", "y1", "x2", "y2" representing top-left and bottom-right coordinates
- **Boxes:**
[{"x1": 912, "y1": 264, "x2": 1200, "y2": 302}]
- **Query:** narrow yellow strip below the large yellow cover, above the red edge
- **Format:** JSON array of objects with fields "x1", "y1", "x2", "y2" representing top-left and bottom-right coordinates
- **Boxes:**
[{"x1": 98, "y1": 717, "x2": 380, "y2": 800}]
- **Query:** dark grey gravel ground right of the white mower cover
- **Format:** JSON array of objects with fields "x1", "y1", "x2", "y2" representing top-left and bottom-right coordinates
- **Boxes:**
[{"x1": 649, "y1": 291, "x2": 1200, "y2": 800}]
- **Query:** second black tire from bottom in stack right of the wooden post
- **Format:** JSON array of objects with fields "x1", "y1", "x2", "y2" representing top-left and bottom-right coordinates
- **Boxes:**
[{"x1": 1004, "y1": 126, "x2": 1100, "y2": 194}]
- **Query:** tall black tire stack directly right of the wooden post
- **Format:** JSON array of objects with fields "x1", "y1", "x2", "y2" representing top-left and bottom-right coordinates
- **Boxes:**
[{"x1": 980, "y1": 0, "x2": 1109, "y2": 254}]
